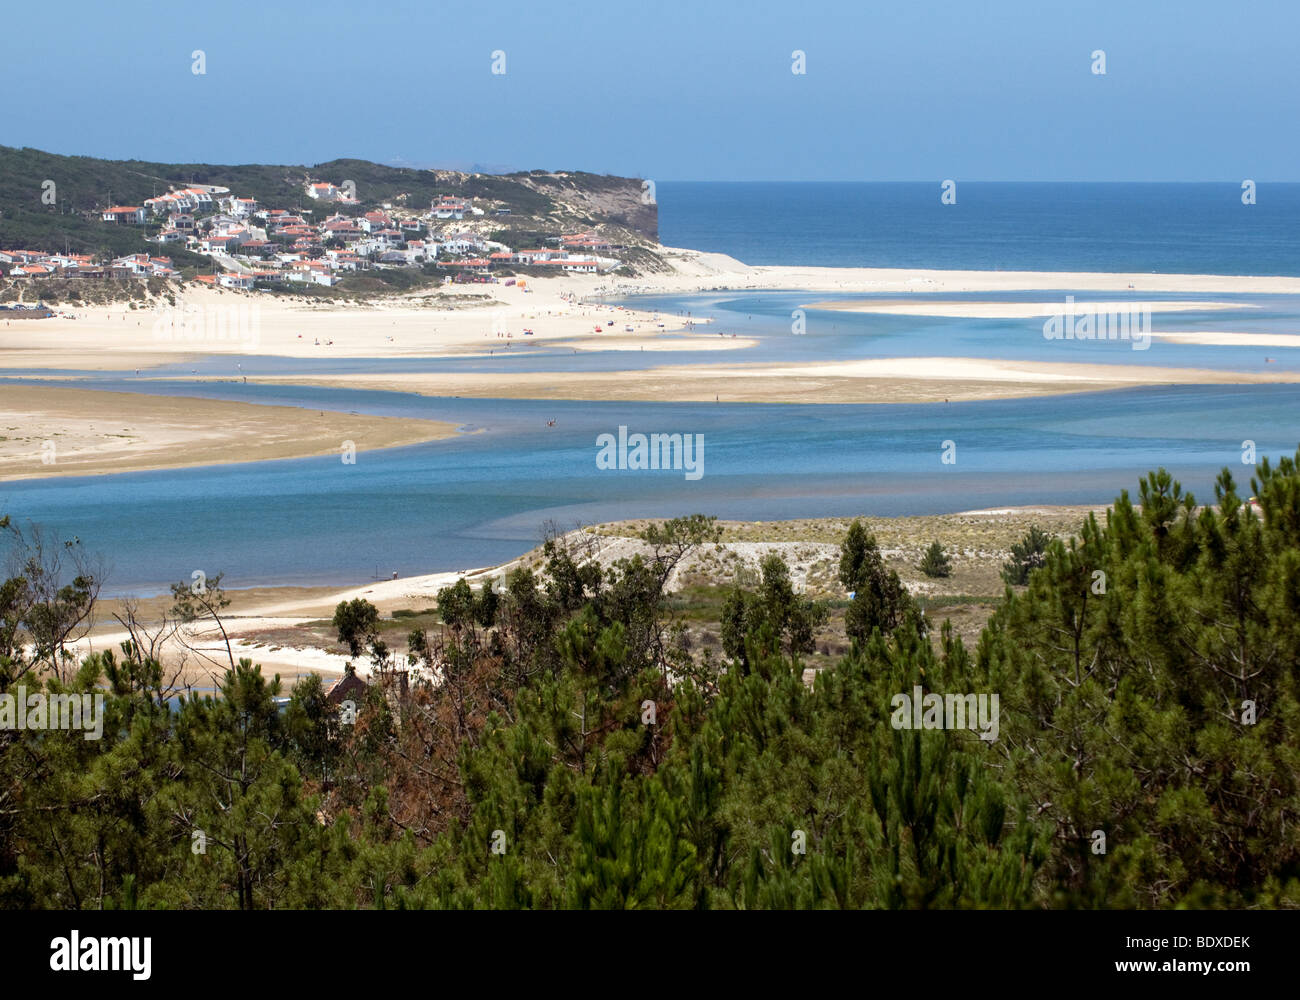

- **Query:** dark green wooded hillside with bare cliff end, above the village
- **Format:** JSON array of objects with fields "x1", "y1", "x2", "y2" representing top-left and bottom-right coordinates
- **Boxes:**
[{"x1": 0, "y1": 146, "x2": 658, "y2": 267}]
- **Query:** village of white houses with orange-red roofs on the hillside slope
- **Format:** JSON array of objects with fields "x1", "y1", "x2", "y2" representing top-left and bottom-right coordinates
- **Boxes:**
[{"x1": 0, "y1": 182, "x2": 620, "y2": 291}]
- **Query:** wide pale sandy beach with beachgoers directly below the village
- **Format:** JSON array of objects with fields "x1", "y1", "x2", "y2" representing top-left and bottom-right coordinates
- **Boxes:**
[{"x1": 0, "y1": 278, "x2": 733, "y2": 372}]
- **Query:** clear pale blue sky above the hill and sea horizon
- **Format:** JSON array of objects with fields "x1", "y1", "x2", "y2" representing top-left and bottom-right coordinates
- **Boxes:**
[{"x1": 0, "y1": 0, "x2": 1300, "y2": 183}]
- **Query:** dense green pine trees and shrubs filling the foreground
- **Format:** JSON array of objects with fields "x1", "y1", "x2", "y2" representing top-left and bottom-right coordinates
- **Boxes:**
[{"x1": 0, "y1": 454, "x2": 1300, "y2": 909}]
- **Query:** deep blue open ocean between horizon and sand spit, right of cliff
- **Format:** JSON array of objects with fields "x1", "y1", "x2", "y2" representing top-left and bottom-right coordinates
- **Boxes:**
[{"x1": 655, "y1": 178, "x2": 1300, "y2": 276}]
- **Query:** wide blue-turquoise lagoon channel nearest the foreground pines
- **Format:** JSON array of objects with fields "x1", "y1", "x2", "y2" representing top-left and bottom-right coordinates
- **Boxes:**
[{"x1": 0, "y1": 384, "x2": 1300, "y2": 594}]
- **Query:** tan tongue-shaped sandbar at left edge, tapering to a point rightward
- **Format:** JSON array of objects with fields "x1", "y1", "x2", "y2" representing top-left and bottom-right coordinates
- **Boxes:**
[{"x1": 0, "y1": 384, "x2": 455, "y2": 481}]
